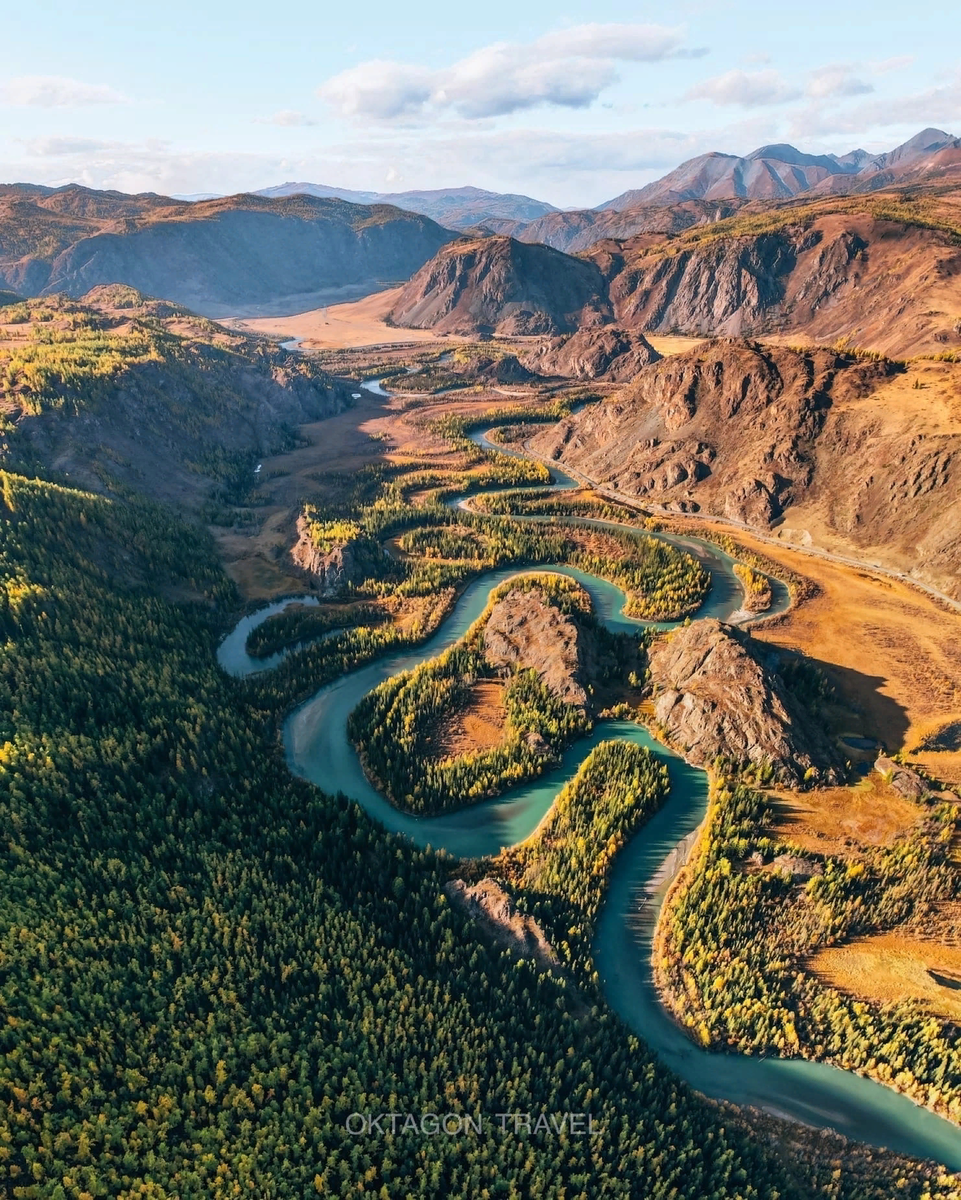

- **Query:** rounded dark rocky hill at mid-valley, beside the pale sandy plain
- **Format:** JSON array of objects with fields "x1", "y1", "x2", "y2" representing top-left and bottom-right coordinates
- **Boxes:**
[{"x1": 390, "y1": 236, "x2": 612, "y2": 336}]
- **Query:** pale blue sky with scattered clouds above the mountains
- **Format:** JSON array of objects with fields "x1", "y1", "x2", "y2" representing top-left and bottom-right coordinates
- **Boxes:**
[{"x1": 0, "y1": 0, "x2": 961, "y2": 208}]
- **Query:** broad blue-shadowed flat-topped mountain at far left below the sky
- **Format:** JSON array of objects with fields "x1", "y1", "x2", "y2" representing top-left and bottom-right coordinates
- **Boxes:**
[{"x1": 0, "y1": 185, "x2": 452, "y2": 317}]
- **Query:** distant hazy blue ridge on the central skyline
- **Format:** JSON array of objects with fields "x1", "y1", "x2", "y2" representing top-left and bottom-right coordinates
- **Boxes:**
[{"x1": 254, "y1": 184, "x2": 558, "y2": 232}]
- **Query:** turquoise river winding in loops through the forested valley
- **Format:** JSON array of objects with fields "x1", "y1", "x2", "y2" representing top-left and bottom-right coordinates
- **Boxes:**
[{"x1": 217, "y1": 384, "x2": 961, "y2": 1171}]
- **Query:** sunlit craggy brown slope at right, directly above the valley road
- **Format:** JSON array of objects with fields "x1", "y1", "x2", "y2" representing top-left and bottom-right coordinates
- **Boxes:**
[{"x1": 530, "y1": 340, "x2": 961, "y2": 596}]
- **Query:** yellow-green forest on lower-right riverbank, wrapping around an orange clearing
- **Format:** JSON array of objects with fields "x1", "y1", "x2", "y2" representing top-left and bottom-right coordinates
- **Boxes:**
[{"x1": 655, "y1": 762, "x2": 961, "y2": 1121}]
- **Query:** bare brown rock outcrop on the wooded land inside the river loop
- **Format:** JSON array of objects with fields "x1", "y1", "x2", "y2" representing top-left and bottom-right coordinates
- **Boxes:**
[{"x1": 483, "y1": 588, "x2": 599, "y2": 709}]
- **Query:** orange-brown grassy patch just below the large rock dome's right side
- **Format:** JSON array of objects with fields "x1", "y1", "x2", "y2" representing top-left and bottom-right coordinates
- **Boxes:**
[{"x1": 774, "y1": 772, "x2": 925, "y2": 856}]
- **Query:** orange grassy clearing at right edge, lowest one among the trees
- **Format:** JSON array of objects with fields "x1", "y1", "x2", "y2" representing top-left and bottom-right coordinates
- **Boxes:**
[{"x1": 807, "y1": 932, "x2": 961, "y2": 1021}]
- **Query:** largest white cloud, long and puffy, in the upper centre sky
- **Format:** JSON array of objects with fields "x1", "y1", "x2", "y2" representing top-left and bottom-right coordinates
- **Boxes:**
[{"x1": 318, "y1": 24, "x2": 702, "y2": 121}]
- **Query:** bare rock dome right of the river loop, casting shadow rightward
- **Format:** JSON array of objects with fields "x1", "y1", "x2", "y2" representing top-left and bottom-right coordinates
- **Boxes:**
[{"x1": 649, "y1": 620, "x2": 841, "y2": 786}]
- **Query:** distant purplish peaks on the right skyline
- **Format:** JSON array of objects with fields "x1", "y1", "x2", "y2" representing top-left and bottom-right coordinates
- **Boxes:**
[{"x1": 599, "y1": 128, "x2": 961, "y2": 211}]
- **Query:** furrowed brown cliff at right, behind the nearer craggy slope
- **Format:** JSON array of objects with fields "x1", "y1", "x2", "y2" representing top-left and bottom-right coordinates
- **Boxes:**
[{"x1": 593, "y1": 214, "x2": 961, "y2": 355}]
